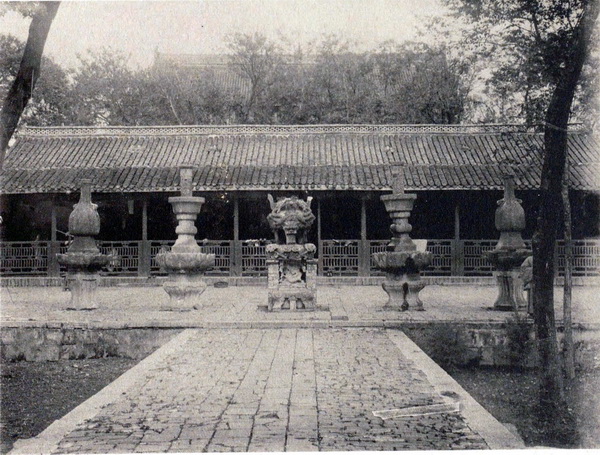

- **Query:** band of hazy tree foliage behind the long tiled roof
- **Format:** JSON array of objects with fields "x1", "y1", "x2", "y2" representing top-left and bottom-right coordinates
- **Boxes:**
[{"x1": 0, "y1": 34, "x2": 470, "y2": 125}]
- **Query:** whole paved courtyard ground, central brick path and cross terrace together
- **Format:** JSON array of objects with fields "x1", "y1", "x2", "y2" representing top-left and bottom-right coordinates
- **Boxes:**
[{"x1": 0, "y1": 286, "x2": 599, "y2": 453}]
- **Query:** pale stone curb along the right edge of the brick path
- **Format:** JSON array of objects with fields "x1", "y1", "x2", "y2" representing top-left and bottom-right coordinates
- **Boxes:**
[{"x1": 386, "y1": 330, "x2": 525, "y2": 450}]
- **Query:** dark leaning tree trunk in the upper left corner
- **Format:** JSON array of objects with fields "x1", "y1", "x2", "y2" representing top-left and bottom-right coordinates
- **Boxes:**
[{"x1": 0, "y1": 2, "x2": 60, "y2": 170}]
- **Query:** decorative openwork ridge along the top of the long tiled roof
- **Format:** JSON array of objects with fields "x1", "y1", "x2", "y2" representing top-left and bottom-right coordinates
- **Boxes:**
[{"x1": 18, "y1": 123, "x2": 582, "y2": 137}]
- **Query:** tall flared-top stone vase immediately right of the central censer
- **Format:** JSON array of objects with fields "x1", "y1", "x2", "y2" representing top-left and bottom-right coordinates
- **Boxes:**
[{"x1": 372, "y1": 167, "x2": 431, "y2": 311}]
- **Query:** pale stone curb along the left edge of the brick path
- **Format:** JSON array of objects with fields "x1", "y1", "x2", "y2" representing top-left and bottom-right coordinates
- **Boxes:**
[{"x1": 9, "y1": 330, "x2": 195, "y2": 455}]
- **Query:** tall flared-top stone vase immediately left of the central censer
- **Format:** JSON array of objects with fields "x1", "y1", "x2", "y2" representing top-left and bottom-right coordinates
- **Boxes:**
[{"x1": 156, "y1": 166, "x2": 215, "y2": 311}]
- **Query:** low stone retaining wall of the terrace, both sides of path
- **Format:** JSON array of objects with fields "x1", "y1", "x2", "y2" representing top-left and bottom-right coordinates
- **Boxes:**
[{"x1": 0, "y1": 322, "x2": 600, "y2": 367}]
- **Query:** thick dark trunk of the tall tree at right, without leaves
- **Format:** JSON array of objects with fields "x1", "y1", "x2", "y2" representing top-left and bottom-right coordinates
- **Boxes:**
[{"x1": 533, "y1": 0, "x2": 599, "y2": 415}]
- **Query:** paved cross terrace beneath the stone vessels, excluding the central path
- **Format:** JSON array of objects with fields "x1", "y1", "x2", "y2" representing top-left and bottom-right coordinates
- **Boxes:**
[{"x1": 0, "y1": 285, "x2": 600, "y2": 328}]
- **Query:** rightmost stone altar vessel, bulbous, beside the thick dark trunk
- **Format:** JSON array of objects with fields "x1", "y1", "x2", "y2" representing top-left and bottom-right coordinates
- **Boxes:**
[{"x1": 485, "y1": 174, "x2": 531, "y2": 311}]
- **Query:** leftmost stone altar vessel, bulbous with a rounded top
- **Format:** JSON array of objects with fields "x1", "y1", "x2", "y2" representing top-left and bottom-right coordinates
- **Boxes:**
[{"x1": 57, "y1": 179, "x2": 115, "y2": 310}]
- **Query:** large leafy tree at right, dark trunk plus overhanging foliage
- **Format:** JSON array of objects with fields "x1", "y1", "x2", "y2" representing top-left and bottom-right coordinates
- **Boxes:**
[{"x1": 447, "y1": 0, "x2": 600, "y2": 442}]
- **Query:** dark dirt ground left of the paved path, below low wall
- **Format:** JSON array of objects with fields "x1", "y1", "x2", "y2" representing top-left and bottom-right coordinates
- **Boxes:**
[{"x1": 0, "y1": 358, "x2": 138, "y2": 453}]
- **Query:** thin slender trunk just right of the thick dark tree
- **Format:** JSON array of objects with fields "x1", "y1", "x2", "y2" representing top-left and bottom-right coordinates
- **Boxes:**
[{"x1": 562, "y1": 167, "x2": 575, "y2": 381}]
